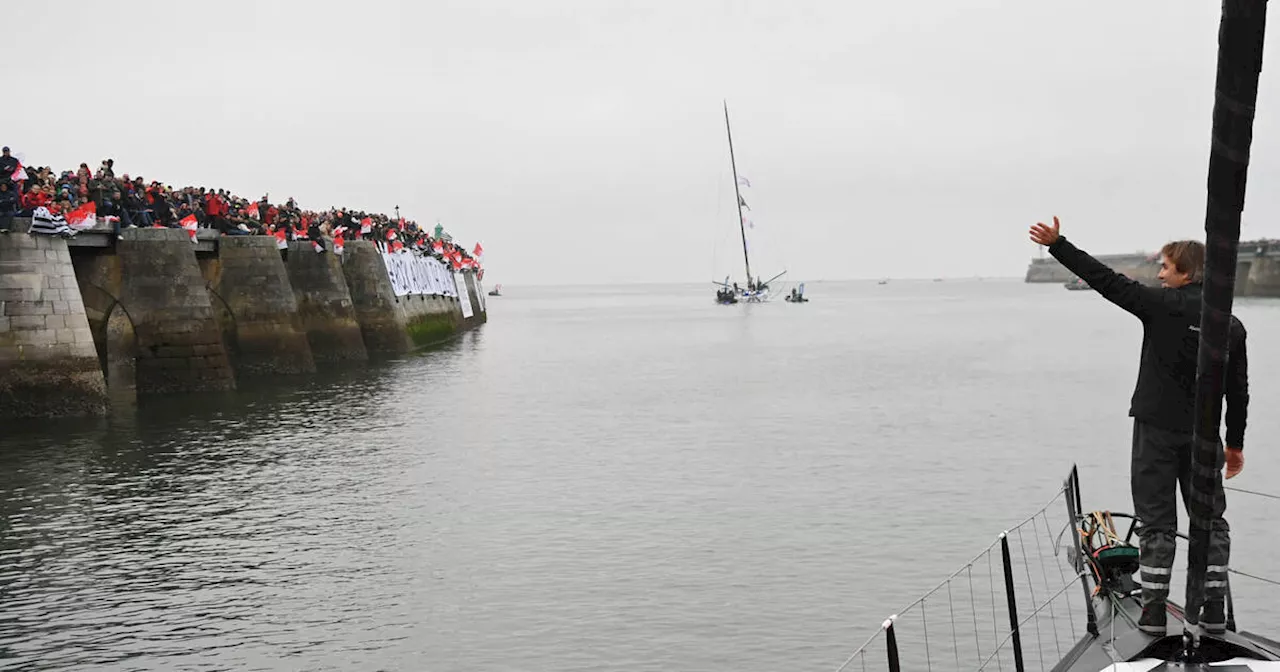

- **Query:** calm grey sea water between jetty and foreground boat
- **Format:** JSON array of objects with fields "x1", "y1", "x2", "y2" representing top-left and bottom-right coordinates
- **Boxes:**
[{"x1": 0, "y1": 280, "x2": 1280, "y2": 671}]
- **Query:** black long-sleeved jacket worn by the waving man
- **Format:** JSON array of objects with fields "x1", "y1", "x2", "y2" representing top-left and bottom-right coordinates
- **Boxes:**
[{"x1": 1048, "y1": 237, "x2": 1249, "y2": 449}]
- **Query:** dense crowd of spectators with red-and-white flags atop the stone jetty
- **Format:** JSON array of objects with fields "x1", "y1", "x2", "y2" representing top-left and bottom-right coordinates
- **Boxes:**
[{"x1": 0, "y1": 147, "x2": 479, "y2": 269}]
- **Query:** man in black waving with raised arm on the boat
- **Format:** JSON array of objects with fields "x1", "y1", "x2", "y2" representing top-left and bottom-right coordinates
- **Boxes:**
[{"x1": 1030, "y1": 218, "x2": 1249, "y2": 635}]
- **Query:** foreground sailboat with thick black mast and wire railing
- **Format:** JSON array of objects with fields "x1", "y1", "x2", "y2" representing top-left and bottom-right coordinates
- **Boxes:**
[{"x1": 837, "y1": 0, "x2": 1280, "y2": 672}]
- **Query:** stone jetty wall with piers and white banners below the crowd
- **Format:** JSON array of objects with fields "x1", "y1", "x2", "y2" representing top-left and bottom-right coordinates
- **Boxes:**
[{"x1": 0, "y1": 219, "x2": 488, "y2": 419}]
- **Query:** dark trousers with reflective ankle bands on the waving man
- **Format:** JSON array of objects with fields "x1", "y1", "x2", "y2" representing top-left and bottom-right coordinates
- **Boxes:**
[{"x1": 1129, "y1": 420, "x2": 1231, "y2": 604}]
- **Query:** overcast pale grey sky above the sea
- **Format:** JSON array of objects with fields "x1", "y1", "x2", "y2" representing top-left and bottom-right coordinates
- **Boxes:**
[{"x1": 10, "y1": 0, "x2": 1280, "y2": 284}]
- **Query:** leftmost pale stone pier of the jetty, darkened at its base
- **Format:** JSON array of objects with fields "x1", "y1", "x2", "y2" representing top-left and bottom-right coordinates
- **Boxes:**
[{"x1": 0, "y1": 227, "x2": 108, "y2": 419}]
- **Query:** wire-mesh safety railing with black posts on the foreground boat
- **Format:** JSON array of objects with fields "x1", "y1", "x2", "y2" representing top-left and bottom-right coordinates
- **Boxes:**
[{"x1": 837, "y1": 468, "x2": 1097, "y2": 672}]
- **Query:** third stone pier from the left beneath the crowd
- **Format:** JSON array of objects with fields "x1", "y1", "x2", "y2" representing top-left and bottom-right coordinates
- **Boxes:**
[{"x1": 200, "y1": 236, "x2": 316, "y2": 375}]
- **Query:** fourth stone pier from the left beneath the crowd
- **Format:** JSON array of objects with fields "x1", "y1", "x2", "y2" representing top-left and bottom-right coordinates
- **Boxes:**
[{"x1": 286, "y1": 238, "x2": 369, "y2": 364}]
